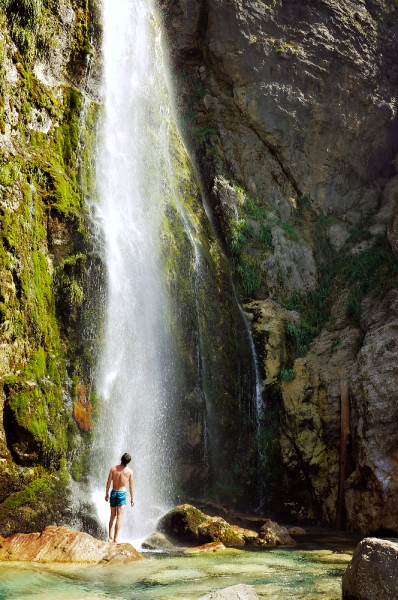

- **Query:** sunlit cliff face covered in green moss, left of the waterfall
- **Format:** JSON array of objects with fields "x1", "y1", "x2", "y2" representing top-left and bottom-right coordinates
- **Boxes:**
[{"x1": 0, "y1": 0, "x2": 101, "y2": 535}]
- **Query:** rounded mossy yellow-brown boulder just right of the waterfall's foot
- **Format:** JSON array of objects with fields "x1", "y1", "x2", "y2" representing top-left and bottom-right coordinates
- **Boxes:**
[{"x1": 157, "y1": 504, "x2": 210, "y2": 543}]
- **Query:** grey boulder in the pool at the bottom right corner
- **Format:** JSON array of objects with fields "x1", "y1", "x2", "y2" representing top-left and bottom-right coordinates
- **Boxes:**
[{"x1": 343, "y1": 538, "x2": 398, "y2": 600}]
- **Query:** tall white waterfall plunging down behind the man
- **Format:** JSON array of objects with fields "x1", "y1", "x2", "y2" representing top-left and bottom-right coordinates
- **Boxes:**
[{"x1": 92, "y1": 0, "x2": 176, "y2": 539}]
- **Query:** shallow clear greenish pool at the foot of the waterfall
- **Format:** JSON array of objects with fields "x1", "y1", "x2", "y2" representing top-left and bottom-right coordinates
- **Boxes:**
[{"x1": 0, "y1": 542, "x2": 356, "y2": 600}]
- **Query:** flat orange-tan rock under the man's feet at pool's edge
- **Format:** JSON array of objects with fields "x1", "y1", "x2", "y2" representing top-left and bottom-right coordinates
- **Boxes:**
[{"x1": 0, "y1": 527, "x2": 142, "y2": 564}]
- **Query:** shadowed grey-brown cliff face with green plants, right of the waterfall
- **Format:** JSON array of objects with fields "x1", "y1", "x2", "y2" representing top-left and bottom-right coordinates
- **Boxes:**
[{"x1": 159, "y1": 0, "x2": 398, "y2": 532}]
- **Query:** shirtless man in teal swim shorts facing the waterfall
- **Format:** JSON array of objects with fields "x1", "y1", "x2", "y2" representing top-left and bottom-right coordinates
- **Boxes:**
[{"x1": 105, "y1": 453, "x2": 134, "y2": 544}]
